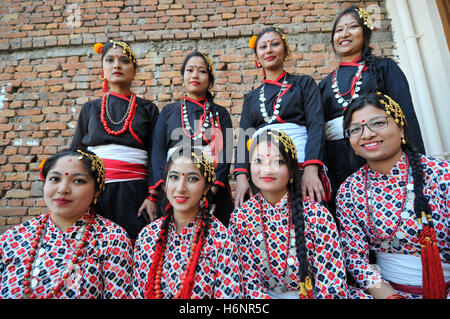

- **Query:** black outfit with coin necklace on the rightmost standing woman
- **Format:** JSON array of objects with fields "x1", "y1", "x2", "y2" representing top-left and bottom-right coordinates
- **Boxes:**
[{"x1": 319, "y1": 57, "x2": 425, "y2": 198}]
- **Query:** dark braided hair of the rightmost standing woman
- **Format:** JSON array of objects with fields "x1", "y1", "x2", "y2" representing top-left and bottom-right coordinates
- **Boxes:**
[{"x1": 331, "y1": 6, "x2": 382, "y2": 92}]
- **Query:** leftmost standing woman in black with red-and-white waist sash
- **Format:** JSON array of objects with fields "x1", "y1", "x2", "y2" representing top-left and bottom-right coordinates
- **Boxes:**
[{"x1": 72, "y1": 40, "x2": 159, "y2": 240}]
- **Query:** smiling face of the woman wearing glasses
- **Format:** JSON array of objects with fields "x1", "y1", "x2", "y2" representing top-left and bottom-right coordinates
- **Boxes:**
[{"x1": 350, "y1": 105, "x2": 404, "y2": 169}]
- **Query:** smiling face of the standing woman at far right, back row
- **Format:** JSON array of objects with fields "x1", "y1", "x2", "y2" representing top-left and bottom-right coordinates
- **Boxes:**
[{"x1": 333, "y1": 14, "x2": 364, "y2": 61}]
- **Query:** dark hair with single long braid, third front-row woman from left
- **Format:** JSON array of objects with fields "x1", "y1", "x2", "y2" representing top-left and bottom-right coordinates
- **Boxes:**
[{"x1": 248, "y1": 130, "x2": 313, "y2": 298}]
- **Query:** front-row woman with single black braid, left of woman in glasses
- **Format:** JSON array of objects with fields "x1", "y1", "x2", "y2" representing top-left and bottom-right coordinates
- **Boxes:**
[{"x1": 230, "y1": 130, "x2": 347, "y2": 299}]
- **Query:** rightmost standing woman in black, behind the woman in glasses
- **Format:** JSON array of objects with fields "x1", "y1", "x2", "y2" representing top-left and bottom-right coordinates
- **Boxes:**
[{"x1": 319, "y1": 6, "x2": 425, "y2": 215}]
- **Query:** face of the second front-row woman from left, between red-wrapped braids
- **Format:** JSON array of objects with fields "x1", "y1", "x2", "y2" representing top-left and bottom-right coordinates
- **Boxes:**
[{"x1": 165, "y1": 157, "x2": 208, "y2": 217}]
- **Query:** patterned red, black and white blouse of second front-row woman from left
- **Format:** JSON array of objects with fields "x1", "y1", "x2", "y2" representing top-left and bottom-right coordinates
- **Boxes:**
[{"x1": 130, "y1": 217, "x2": 240, "y2": 299}]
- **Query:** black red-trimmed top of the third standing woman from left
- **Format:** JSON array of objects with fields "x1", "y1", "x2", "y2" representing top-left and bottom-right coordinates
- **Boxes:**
[{"x1": 234, "y1": 72, "x2": 325, "y2": 174}]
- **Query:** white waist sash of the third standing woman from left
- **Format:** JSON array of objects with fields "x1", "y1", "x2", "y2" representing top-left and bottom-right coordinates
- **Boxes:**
[{"x1": 252, "y1": 123, "x2": 308, "y2": 163}]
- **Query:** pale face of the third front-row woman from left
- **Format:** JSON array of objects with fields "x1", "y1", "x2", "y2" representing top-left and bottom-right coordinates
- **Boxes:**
[{"x1": 250, "y1": 141, "x2": 290, "y2": 203}]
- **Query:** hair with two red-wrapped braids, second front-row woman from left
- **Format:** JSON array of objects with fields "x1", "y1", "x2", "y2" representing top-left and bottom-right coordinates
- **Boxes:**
[{"x1": 144, "y1": 148, "x2": 214, "y2": 299}]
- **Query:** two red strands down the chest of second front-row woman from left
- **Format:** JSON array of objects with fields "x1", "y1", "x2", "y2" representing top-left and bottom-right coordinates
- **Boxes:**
[{"x1": 154, "y1": 219, "x2": 203, "y2": 299}]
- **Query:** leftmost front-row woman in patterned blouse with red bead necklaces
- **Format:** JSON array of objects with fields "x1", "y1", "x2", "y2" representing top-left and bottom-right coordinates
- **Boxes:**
[{"x1": 0, "y1": 149, "x2": 133, "y2": 299}]
